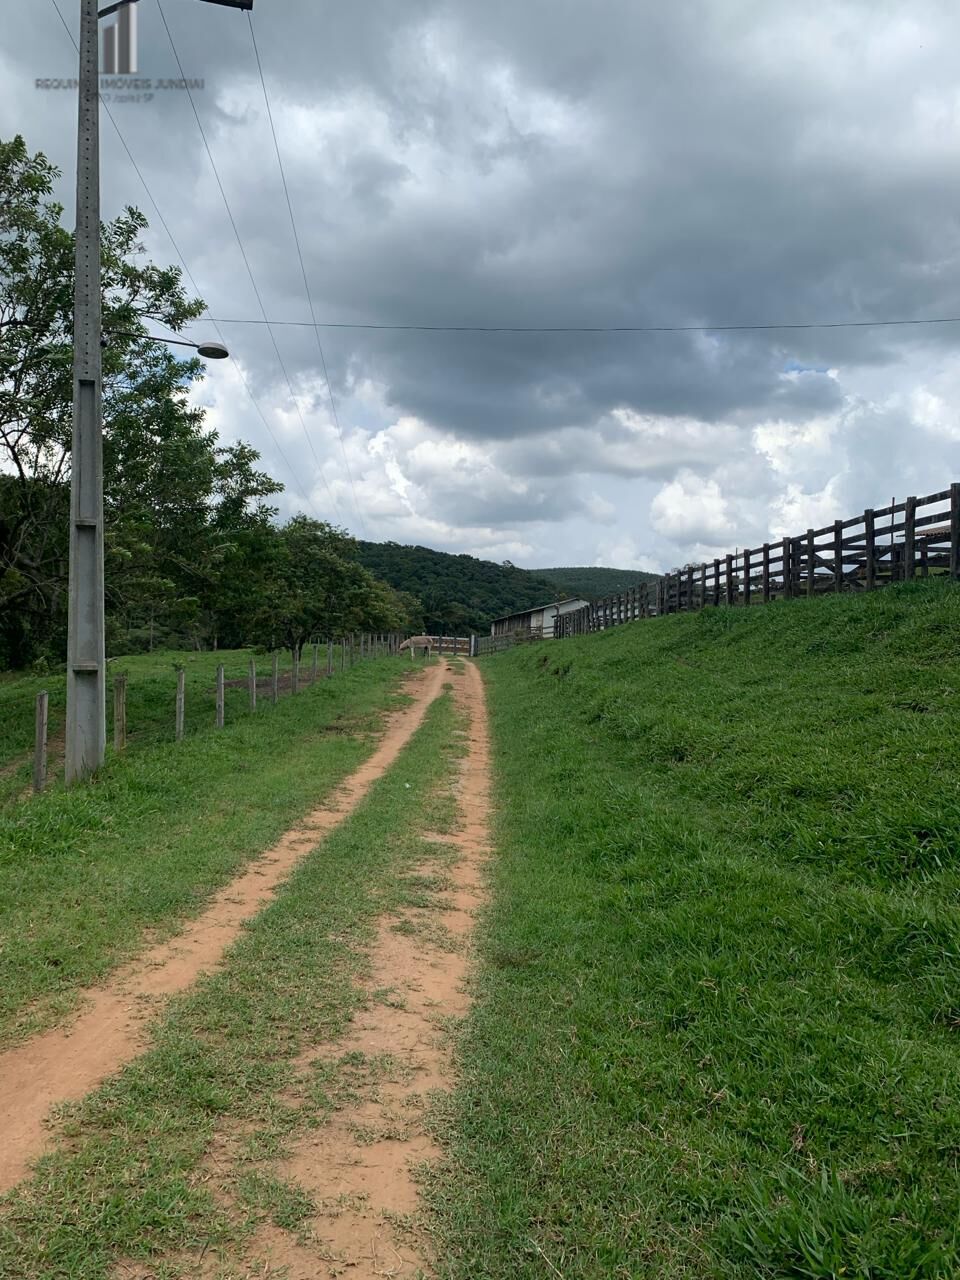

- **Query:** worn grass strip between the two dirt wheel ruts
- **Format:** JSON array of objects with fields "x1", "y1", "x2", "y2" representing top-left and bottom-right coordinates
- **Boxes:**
[{"x1": 0, "y1": 686, "x2": 463, "y2": 1280}]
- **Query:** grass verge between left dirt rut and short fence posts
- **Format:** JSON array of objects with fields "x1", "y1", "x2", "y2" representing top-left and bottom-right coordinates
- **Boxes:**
[{"x1": 0, "y1": 654, "x2": 407, "y2": 1044}]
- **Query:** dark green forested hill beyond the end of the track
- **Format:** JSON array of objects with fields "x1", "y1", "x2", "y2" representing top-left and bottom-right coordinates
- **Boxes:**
[{"x1": 357, "y1": 541, "x2": 572, "y2": 635}]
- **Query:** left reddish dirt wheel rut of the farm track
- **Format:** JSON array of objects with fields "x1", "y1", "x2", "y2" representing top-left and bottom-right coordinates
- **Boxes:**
[{"x1": 0, "y1": 667, "x2": 444, "y2": 1194}]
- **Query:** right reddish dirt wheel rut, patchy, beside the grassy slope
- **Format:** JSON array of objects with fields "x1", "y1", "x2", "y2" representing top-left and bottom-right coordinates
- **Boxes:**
[{"x1": 241, "y1": 663, "x2": 489, "y2": 1280}]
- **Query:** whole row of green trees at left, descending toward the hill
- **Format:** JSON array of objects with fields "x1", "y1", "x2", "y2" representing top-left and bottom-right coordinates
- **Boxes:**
[{"x1": 0, "y1": 137, "x2": 424, "y2": 668}]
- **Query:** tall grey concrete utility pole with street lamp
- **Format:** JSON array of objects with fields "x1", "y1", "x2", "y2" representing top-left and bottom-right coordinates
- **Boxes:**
[{"x1": 65, "y1": 0, "x2": 253, "y2": 783}]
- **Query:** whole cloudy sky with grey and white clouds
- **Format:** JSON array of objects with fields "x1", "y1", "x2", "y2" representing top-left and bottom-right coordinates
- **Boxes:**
[{"x1": 0, "y1": 0, "x2": 960, "y2": 570}]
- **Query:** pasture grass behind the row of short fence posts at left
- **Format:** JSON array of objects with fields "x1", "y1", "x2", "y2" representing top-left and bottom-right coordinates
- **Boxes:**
[{"x1": 0, "y1": 648, "x2": 327, "y2": 806}]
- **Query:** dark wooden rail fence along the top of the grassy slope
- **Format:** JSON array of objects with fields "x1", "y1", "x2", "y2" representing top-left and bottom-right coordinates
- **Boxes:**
[{"x1": 554, "y1": 484, "x2": 960, "y2": 640}]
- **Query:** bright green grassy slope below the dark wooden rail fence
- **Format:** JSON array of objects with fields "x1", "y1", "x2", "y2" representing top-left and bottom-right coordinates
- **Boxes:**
[{"x1": 430, "y1": 584, "x2": 960, "y2": 1280}]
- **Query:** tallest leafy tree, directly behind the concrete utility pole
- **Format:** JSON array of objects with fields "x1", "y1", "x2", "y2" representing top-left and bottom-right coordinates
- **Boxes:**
[{"x1": 0, "y1": 137, "x2": 282, "y2": 666}]
